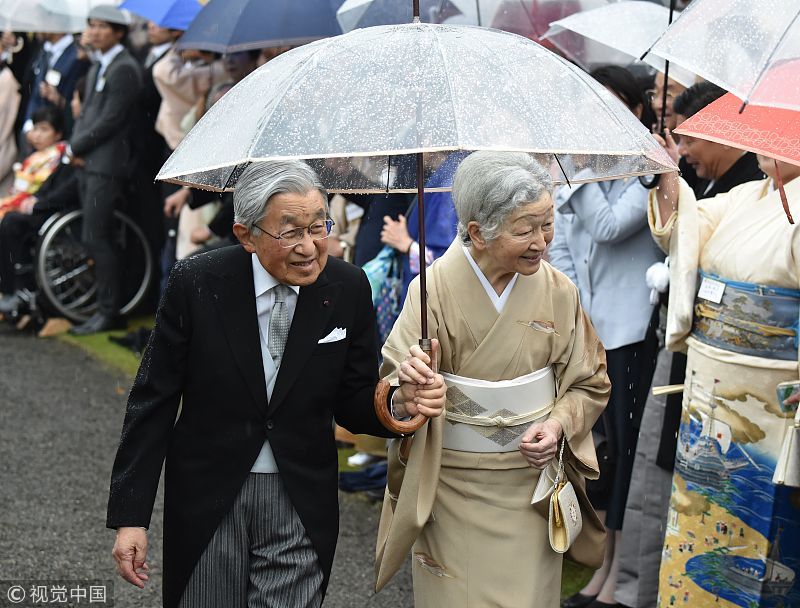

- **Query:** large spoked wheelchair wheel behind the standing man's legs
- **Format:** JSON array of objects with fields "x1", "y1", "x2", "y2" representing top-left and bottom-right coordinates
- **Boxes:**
[{"x1": 35, "y1": 210, "x2": 153, "y2": 323}]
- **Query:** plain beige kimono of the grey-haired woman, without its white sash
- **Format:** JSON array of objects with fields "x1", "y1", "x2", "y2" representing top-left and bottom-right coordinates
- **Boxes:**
[{"x1": 376, "y1": 242, "x2": 610, "y2": 608}]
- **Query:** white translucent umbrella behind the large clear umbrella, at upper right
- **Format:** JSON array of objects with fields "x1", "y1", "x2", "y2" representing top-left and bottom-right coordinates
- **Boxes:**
[{"x1": 544, "y1": 0, "x2": 695, "y2": 87}]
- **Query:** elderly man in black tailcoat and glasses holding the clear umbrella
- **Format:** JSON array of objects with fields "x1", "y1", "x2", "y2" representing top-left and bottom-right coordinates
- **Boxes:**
[{"x1": 107, "y1": 161, "x2": 445, "y2": 608}]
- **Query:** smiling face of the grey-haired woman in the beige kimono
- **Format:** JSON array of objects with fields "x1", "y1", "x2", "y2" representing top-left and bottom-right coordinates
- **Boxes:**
[{"x1": 486, "y1": 193, "x2": 554, "y2": 275}]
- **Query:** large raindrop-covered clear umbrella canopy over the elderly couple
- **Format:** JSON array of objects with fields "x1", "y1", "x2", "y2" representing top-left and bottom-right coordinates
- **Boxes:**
[{"x1": 158, "y1": 23, "x2": 676, "y2": 192}]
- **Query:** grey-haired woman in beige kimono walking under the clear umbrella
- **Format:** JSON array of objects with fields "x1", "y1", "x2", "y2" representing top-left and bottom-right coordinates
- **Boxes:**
[{"x1": 376, "y1": 152, "x2": 610, "y2": 608}]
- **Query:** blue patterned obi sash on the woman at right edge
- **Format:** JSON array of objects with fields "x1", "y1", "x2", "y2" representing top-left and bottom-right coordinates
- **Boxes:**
[{"x1": 692, "y1": 272, "x2": 800, "y2": 361}]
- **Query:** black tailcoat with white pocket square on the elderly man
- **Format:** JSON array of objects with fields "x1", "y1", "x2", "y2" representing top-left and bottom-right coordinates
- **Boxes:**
[{"x1": 107, "y1": 245, "x2": 396, "y2": 608}]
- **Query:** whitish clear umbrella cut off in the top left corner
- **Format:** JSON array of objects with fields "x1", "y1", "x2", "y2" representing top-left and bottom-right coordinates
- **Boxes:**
[{"x1": 0, "y1": 0, "x2": 120, "y2": 32}]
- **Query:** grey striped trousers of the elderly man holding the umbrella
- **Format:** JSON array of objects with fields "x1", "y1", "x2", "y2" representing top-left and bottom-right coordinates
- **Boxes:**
[{"x1": 180, "y1": 473, "x2": 322, "y2": 608}]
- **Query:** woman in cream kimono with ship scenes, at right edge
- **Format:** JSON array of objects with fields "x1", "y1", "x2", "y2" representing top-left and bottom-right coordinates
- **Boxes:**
[{"x1": 649, "y1": 156, "x2": 800, "y2": 608}]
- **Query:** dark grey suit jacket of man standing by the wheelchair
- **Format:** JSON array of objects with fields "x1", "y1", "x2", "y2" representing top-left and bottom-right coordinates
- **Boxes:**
[{"x1": 70, "y1": 49, "x2": 142, "y2": 177}]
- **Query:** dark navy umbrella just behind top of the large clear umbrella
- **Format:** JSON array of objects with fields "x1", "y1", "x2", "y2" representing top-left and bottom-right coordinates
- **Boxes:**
[{"x1": 178, "y1": 0, "x2": 342, "y2": 53}]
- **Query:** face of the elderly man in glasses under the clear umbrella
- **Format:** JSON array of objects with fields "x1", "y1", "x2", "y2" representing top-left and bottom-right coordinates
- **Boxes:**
[{"x1": 234, "y1": 190, "x2": 328, "y2": 286}]
